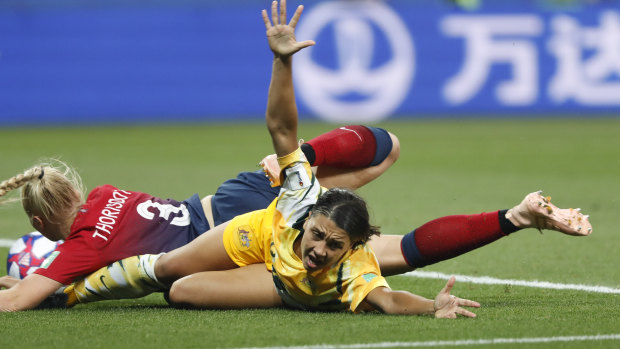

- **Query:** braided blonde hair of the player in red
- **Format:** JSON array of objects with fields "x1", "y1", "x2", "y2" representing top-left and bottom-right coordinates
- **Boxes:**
[{"x1": 0, "y1": 159, "x2": 85, "y2": 221}]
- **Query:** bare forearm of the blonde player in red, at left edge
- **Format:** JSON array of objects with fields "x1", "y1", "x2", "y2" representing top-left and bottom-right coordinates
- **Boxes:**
[{"x1": 0, "y1": 274, "x2": 62, "y2": 311}]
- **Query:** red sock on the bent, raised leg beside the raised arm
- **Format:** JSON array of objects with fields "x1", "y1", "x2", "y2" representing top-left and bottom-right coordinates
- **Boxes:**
[{"x1": 302, "y1": 125, "x2": 377, "y2": 168}]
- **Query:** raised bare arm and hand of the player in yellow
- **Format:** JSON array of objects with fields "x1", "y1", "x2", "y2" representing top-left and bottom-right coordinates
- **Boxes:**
[{"x1": 262, "y1": 0, "x2": 314, "y2": 157}]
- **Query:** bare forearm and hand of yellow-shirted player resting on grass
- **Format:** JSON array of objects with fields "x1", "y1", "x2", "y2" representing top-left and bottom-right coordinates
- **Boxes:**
[{"x1": 366, "y1": 277, "x2": 480, "y2": 319}]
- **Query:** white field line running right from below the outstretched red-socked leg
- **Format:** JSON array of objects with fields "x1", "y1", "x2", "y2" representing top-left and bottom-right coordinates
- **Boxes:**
[{"x1": 403, "y1": 270, "x2": 620, "y2": 294}]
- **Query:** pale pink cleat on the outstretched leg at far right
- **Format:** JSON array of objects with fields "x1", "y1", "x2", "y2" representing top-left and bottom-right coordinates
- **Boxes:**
[{"x1": 506, "y1": 191, "x2": 592, "y2": 236}]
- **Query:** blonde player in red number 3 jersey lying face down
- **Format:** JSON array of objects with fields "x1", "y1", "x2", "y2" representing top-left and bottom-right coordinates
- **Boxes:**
[{"x1": 0, "y1": 121, "x2": 400, "y2": 310}]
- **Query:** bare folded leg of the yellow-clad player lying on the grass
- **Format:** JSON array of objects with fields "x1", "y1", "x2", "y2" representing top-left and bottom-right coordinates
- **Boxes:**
[{"x1": 168, "y1": 263, "x2": 282, "y2": 309}]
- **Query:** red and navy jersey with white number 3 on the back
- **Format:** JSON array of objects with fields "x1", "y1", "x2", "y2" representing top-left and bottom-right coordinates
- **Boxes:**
[{"x1": 35, "y1": 185, "x2": 208, "y2": 284}]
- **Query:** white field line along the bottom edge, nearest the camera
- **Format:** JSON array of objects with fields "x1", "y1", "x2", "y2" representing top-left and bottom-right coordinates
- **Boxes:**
[{"x1": 231, "y1": 334, "x2": 620, "y2": 349}]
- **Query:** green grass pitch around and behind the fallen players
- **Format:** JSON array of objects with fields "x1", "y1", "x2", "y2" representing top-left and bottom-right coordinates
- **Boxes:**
[{"x1": 0, "y1": 118, "x2": 620, "y2": 349}]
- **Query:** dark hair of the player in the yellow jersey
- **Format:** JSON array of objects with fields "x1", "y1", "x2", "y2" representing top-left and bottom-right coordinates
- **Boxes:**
[{"x1": 312, "y1": 188, "x2": 380, "y2": 246}]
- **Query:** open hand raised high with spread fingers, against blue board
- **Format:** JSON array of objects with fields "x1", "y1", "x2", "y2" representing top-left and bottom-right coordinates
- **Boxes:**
[{"x1": 262, "y1": 0, "x2": 314, "y2": 57}]
